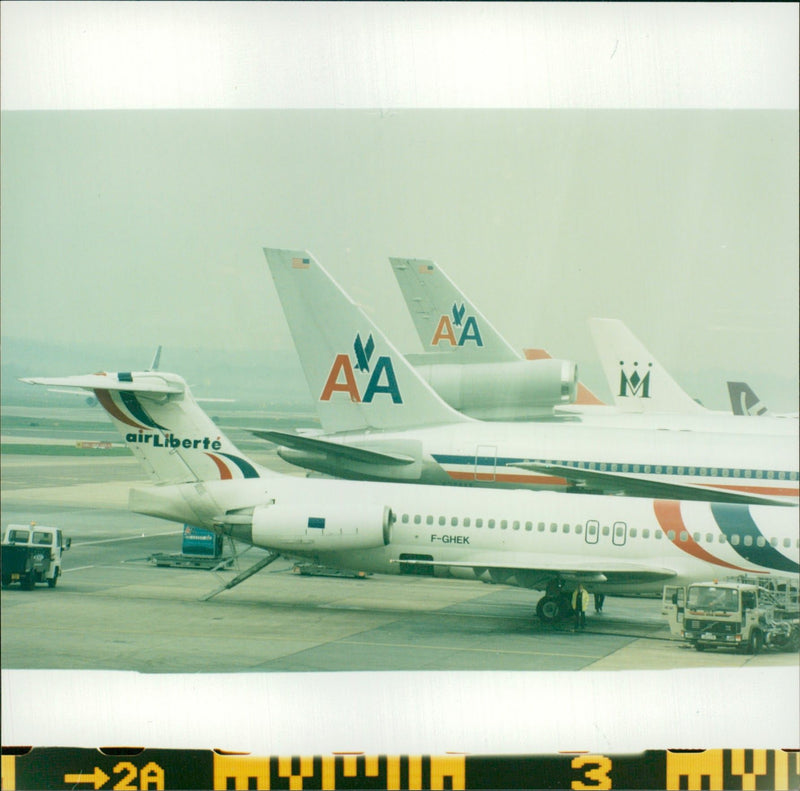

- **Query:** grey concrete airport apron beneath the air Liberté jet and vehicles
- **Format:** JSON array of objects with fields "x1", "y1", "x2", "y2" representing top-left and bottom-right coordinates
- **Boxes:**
[{"x1": 2, "y1": 452, "x2": 798, "y2": 673}]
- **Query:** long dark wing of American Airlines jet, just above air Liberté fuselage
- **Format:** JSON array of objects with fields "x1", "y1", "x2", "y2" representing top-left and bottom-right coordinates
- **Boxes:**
[{"x1": 508, "y1": 461, "x2": 796, "y2": 507}]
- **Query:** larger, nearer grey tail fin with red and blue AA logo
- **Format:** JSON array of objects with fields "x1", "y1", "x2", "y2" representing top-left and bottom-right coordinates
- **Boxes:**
[{"x1": 264, "y1": 248, "x2": 469, "y2": 432}]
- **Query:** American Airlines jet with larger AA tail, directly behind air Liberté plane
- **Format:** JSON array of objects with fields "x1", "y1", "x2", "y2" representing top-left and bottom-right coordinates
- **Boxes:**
[{"x1": 255, "y1": 249, "x2": 798, "y2": 505}]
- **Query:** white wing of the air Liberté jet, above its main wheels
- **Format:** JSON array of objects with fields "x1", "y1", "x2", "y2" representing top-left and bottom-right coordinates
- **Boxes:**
[{"x1": 392, "y1": 552, "x2": 676, "y2": 583}]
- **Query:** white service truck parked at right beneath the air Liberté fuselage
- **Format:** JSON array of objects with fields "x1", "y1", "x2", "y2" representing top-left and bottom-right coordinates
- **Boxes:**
[{"x1": 662, "y1": 577, "x2": 800, "y2": 654}]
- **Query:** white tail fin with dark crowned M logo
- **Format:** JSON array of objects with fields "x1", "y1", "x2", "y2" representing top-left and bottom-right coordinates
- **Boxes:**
[{"x1": 589, "y1": 319, "x2": 706, "y2": 414}]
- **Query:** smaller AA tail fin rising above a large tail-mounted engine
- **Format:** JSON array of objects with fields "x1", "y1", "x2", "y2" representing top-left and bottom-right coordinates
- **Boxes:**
[{"x1": 389, "y1": 258, "x2": 521, "y2": 363}]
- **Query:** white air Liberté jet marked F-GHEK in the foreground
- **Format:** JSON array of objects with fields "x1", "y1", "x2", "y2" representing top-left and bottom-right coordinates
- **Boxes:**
[{"x1": 22, "y1": 368, "x2": 800, "y2": 621}]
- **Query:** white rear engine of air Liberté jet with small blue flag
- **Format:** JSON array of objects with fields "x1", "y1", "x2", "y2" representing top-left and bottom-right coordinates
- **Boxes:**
[{"x1": 252, "y1": 503, "x2": 394, "y2": 552}]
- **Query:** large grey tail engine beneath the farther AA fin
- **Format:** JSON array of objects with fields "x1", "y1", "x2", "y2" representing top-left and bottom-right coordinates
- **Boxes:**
[{"x1": 415, "y1": 359, "x2": 578, "y2": 420}]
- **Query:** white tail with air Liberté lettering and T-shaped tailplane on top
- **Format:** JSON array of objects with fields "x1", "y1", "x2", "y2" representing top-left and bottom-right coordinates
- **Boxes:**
[{"x1": 21, "y1": 371, "x2": 269, "y2": 484}]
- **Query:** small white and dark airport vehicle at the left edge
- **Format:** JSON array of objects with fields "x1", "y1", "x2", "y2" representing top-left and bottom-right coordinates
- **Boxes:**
[{"x1": 2, "y1": 522, "x2": 72, "y2": 590}]
